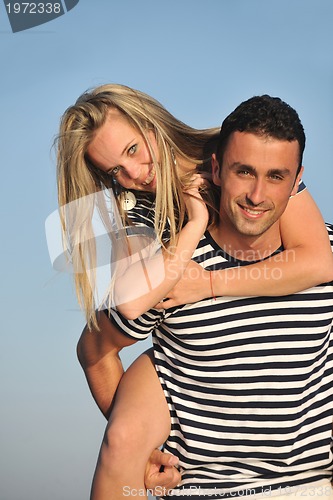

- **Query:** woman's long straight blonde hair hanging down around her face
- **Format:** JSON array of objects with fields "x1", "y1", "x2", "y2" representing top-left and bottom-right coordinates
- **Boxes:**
[{"x1": 56, "y1": 84, "x2": 219, "y2": 327}]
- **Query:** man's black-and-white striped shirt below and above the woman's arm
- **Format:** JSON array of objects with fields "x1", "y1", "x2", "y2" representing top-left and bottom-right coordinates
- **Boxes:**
[{"x1": 107, "y1": 189, "x2": 333, "y2": 499}]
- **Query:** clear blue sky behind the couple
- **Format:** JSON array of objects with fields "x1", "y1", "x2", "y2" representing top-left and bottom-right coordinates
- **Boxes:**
[{"x1": 0, "y1": 0, "x2": 333, "y2": 500}]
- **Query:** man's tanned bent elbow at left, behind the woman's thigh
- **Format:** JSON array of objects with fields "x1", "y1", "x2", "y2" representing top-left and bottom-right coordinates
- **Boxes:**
[{"x1": 77, "y1": 312, "x2": 136, "y2": 419}]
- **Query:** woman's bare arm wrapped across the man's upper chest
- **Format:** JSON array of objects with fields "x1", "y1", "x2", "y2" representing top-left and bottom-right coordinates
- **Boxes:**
[{"x1": 158, "y1": 190, "x2": 333, "y2": 309}]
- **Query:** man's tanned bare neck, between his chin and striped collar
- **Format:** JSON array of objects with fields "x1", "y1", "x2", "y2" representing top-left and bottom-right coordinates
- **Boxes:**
[{"x1": 209, "y1": 222, "x2": 282, "y2": 262}]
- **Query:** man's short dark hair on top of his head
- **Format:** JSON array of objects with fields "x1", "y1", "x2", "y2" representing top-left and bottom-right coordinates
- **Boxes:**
[{"x1": 216, "y1": 95, "x2": 305, "y2": 173}]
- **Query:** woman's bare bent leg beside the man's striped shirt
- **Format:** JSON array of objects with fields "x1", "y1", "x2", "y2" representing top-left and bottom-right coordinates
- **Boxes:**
[{"x1": 91, "y1": 353, "x2": 170, "y2": 500}]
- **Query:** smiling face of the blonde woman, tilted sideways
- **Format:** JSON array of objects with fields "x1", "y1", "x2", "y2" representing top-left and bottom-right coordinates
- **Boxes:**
[{"x1": 87, "y1": 110, "x2": 159, "y2": 193}]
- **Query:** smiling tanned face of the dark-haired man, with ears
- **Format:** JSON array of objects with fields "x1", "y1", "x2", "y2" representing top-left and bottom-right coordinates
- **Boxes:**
[{"x1": 213, "y1": 132, "x2": 303, "y2": 237}]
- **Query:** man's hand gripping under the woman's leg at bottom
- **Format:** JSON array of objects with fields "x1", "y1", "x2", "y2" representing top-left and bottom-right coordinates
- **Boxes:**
[{"x1": 145, "y1": 450, "x2": 181, "y2": 496}]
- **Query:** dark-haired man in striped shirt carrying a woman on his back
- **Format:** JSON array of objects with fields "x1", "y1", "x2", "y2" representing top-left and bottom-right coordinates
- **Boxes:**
[{"x1": 79, "y1": 96, "x2": 333, "y2": 499}]
